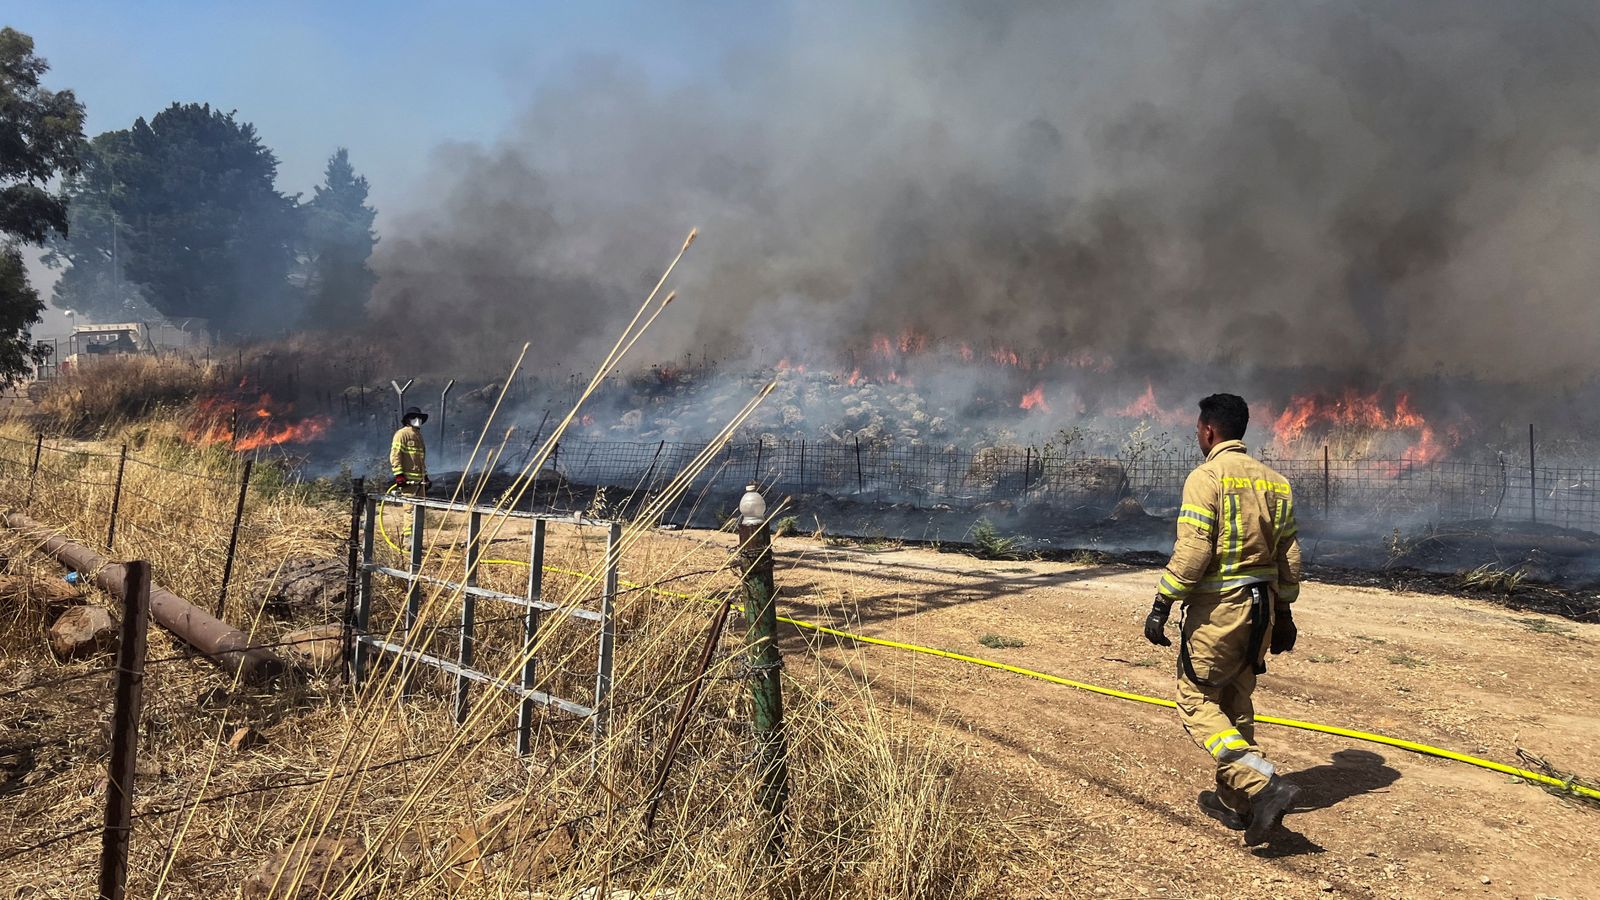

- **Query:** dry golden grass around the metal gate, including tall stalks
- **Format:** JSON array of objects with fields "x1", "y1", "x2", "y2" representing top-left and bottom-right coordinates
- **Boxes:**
[{"x1": 0, "y1": 235, "x2": 1013, "y2": 900}]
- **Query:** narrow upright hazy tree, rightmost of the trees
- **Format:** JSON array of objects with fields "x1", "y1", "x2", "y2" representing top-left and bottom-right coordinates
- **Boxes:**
[{"x1": 302, "y1": 147, "x2": 378, "y2": 330}]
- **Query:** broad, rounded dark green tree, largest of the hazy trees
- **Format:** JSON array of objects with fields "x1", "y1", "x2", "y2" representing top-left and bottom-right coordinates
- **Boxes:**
[{"x1": 96, "y1": 102, "x2": 302, "y2": 336}]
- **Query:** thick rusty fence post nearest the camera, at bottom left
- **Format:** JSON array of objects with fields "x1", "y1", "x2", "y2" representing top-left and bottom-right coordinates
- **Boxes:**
[{"x1": 99, "y1": 560, "x2": 150, "y2": 900}]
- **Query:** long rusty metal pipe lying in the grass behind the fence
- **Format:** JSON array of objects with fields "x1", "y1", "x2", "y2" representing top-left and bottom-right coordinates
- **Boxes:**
[{"x1": 5, "y1": 512, "x2": 288, "y2": 684}]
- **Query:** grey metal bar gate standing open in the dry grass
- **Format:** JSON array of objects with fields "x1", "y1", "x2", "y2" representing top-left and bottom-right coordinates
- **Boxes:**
[{"x1": 352, "y1": 493, "x2": 622, "y2": 754}]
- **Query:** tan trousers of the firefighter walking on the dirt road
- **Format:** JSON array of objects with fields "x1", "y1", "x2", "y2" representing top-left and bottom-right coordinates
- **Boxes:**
[{"x1": 1178, "y1": 586, "x2": 1274, "y2": 812}]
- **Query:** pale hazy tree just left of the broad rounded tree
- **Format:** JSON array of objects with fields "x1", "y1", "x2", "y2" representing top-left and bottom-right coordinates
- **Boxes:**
[{"x1": 45, "y1": 131, "x2": 149, "y2": 322}]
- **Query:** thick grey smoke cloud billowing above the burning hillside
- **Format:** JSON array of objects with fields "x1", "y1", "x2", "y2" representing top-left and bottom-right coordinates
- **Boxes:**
[{"x1": 374, "y1": 0, "x2": 1600, "y2": 380}]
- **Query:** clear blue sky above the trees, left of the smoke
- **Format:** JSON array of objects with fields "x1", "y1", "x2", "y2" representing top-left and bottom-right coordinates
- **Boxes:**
[{"x1": 12, "y1": 0, "x2": 779, "y2": 229}]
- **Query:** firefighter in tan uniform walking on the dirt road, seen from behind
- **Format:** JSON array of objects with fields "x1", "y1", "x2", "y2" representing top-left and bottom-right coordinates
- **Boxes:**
[{"x1": 1144, "y1": 394, "x2": 1301, "y2": 844}]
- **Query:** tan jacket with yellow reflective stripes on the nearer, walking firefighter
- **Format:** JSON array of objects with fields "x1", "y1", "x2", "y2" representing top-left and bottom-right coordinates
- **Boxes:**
[{"x1": 1157, "y1": 440, "x2": 1301, "y2": 605}]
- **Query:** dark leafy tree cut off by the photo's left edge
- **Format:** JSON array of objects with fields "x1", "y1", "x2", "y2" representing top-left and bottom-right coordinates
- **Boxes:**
[{"x1": 0, "y1": 29, "x2": 83, "y2": 384}]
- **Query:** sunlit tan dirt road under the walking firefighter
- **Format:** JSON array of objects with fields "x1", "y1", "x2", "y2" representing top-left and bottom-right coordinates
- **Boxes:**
[{"x1": 681, "y1": 528, "x2": 1600, "y2": 898}]
